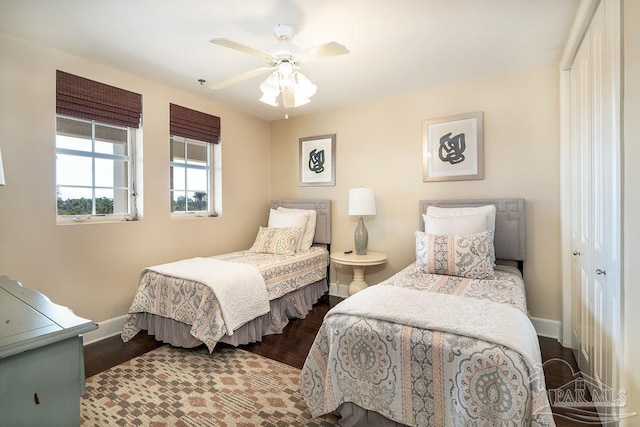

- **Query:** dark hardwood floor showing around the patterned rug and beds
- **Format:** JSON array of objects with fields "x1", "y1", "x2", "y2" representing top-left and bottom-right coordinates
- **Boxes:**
[{"x1": 84, "y1": 295, "x2": 598, "y2": 427}]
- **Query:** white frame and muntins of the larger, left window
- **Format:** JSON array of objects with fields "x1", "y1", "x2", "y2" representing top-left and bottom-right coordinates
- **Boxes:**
[{"x1": 55, "y1": 114, "x2": 139, "y2": 224}]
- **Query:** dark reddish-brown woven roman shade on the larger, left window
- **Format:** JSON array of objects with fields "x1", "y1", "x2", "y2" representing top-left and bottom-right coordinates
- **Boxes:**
[{"x1": 56, "y1": 70, "x2": 142, "y2": 129}]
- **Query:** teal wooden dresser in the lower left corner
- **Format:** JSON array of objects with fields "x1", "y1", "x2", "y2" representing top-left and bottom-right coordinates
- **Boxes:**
[{"x1": 0, "y1": 276, "x2": 98, "y2": 427}]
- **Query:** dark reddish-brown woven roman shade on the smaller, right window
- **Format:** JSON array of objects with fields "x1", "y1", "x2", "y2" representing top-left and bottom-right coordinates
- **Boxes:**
[{"x1": 169, "y1": 104, "x2": 220, "y2": 144}]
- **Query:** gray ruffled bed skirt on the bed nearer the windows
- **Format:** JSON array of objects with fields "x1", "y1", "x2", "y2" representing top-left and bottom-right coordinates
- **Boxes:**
[{"x1": 134, "y1": 279, "x2": 329, "y2": 348}]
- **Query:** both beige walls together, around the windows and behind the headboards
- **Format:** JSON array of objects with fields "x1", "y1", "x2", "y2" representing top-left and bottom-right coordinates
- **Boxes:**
[{"x1": 0, "y1": 35, "x2": 560, "y2": 328}]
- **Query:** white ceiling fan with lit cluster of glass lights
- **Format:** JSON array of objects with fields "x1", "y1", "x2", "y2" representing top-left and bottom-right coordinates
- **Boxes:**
[{"x1": 210, "y1": 24, "x2": 349, "y2": 109}]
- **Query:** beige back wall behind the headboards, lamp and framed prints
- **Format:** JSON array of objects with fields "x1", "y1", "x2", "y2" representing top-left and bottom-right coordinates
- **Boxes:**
[{"x1": 271, "y1": 66, "x2": 561, "y2": 320}]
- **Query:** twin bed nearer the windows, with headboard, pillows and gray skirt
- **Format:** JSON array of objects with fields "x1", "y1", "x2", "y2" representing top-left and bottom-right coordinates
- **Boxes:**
[{"x1": 122, "y1": 199, "x2": 331, "y2": 351}]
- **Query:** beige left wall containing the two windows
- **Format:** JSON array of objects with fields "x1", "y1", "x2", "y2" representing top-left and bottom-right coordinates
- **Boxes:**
[{"x1": 0, "y1": 34, "x2": 270, "y2": 321}]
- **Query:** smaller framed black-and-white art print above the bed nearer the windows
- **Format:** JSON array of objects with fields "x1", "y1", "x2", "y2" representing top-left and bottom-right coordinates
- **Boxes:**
[{"x1": 298, "y1": 134, "x2": 336, "y2": 187}]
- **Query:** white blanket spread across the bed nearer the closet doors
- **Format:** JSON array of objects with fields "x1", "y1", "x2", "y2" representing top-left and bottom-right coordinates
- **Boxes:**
[{"x1": 326, "y1": 284, "x2": 541, "y2": 368}]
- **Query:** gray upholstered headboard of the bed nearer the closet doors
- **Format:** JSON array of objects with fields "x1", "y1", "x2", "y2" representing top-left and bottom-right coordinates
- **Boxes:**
[{"x1": 420, "y1": 198, "x2": 526, "y2": 261}]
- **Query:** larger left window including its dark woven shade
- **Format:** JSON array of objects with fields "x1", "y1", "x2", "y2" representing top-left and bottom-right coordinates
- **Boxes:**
[{"x1": 56, "y1": 70, "x2": 142, "y2": 223}]
